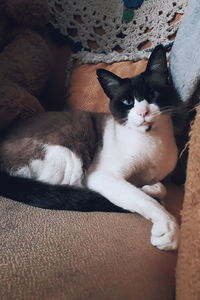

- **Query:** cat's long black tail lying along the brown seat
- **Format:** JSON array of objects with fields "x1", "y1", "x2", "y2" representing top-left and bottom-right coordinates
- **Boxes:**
[{"x1": 0, "y1": 173, "x2": 127, "y2": 212}]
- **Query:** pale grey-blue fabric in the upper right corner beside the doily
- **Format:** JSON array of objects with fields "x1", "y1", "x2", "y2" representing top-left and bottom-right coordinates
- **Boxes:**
[{"x1": 170, "y1": 0, "x2": 200, "y2": 101}]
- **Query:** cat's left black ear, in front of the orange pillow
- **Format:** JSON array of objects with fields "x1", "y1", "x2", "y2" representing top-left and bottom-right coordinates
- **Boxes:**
[{"x1": 96, "y1": 69, "x2": 123, "y2": 98}]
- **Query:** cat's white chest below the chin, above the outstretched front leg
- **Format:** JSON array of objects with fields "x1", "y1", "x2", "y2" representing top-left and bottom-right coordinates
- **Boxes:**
[{"x1": 91, "y1": 120, "x2": 177, "y2": 185}]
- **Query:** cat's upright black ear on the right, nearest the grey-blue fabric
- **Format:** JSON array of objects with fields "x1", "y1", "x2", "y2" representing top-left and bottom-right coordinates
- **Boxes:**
[{"x1": 146, "y1": 45, "x2": 168, "y2": 79}]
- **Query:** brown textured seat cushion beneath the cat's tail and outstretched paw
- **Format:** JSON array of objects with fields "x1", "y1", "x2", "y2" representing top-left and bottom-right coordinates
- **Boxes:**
[{"x1": 0, "y1": 186, "x2": 183, "y2": 300}]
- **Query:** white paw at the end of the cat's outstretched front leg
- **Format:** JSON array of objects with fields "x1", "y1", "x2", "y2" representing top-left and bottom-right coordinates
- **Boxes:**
[{"x1": 151, "y1": 218, "x2": 179, "y2": 251}]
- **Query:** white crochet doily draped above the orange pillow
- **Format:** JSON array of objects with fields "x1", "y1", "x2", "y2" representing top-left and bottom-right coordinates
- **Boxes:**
[{"x1": 49, "y1": 0, "x2": 189, "y2": 63}]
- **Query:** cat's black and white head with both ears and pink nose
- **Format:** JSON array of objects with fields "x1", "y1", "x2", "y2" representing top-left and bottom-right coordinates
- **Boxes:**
[{"x1": 97, "y1": 45, "x2": 183, "y2": 131}]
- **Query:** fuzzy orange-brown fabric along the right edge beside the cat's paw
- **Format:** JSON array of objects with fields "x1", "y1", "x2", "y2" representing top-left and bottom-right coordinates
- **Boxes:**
[{"x1": 176, "y1": 107, "x2": 200, "y2": 300}]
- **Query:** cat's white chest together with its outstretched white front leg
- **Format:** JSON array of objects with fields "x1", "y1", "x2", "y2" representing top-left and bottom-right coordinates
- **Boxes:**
[{"x1": 86, "y1": 115, "x2": 179, "y2": 250}]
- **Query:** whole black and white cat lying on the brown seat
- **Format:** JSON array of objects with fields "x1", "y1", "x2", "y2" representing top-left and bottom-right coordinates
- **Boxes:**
[{"x1": 0, "y1": 46, "x2": 183, "y2": 250}]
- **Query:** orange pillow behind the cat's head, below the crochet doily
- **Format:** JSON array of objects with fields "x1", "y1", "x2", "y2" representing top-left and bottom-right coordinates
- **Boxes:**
[{"x1": 67, "y1": 60, "x2": 147, "y2": 112}]
